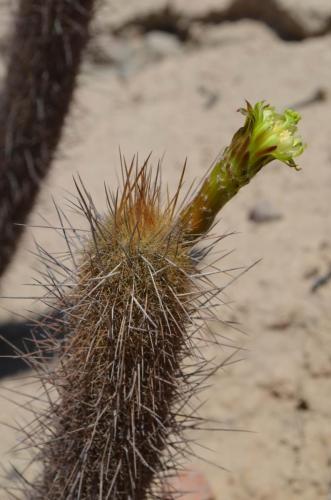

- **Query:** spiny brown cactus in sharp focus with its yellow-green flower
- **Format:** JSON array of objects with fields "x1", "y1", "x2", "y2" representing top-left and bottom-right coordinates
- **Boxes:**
[{"x1": 9, "y1": 103, "x2": 303, "y2": 500}]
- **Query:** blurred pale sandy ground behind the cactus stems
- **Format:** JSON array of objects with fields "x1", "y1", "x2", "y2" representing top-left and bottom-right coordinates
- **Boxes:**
[{"x1": 0, "y1": 0, "x2": 331, "y2": 500}]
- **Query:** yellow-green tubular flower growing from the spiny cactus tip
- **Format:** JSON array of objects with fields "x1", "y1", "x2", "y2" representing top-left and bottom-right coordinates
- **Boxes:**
[{"x1": 179, "y1": 101, "x2": 304, "y2": 238}]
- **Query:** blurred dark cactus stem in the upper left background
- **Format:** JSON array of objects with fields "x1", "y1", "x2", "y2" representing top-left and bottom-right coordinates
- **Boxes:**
[{"x1": 0, "y1": 0, "x2": 95, "y2": 276}]
